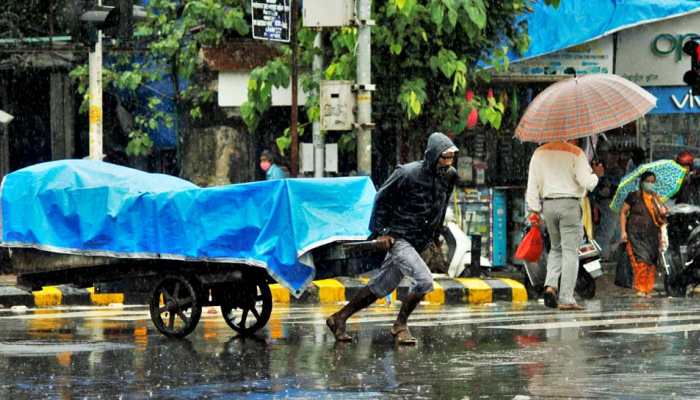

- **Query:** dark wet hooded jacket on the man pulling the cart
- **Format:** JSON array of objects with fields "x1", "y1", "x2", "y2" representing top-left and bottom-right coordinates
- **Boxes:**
[{"x1": 369, "y1": 132, "x2": 456, "y2": 252}]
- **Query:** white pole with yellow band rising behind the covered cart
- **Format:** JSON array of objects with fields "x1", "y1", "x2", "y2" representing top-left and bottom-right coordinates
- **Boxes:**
[{"x1": 88, "y1": 0, "x2": 103, "y2": 160}]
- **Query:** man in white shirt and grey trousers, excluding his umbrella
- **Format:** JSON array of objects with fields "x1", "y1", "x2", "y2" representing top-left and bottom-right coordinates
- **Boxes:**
[{"x1": 526, "y1": 141, "x2": 604, "y2": 310}]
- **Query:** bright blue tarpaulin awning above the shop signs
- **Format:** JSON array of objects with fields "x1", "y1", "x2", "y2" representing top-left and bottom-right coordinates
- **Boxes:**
[{"x1": 509, "y1": 0, "x2": 700, "y2": 60}]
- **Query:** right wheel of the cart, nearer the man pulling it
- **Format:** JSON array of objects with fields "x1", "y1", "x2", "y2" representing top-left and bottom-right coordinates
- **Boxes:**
[{"x1": 221, "y1": 279, "x2": 272, "y2": 335}]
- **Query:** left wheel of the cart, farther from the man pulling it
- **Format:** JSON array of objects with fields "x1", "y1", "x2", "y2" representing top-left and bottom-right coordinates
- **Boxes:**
[{"x1": 150, "y1": 276, "x2": 202, "y2": 338}]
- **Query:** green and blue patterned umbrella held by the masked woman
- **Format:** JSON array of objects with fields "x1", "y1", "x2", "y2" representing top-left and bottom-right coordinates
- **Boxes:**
[{"x1": 610, "y1": 160, "x2": 686, "y2": 211}]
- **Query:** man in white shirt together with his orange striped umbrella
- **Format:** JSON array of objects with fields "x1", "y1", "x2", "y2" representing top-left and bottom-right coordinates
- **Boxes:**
[{"x1": 515, "y1": 74, "x2": 656, "y2": 310}]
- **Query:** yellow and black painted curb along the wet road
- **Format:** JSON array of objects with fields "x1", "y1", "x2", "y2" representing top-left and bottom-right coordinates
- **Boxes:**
[{"x1": 0, "y1": 277, "x2": 527, "y2": 308}]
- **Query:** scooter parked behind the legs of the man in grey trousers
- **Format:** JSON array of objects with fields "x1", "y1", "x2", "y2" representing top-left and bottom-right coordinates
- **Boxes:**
[{"x1": 521, "y1": 222, "x2": 603, "y2": 300}]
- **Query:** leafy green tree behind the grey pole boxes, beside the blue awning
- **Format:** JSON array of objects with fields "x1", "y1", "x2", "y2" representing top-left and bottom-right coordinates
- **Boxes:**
[{"x1": 241, "y1": 0, "x2": 559, "y2": 157}]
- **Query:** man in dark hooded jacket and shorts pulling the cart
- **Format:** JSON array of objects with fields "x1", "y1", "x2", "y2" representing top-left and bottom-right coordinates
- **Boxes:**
[{"x1": 326, "y1": 132, "x2": 458, "y2": 345}]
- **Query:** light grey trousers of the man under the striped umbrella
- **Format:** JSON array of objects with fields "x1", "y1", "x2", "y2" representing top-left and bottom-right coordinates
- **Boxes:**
[{"x1": 542, "y1": 199, "x2": 583, "y2": 304}]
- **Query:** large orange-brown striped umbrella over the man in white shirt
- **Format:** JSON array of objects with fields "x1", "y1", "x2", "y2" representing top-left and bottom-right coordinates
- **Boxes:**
[{"x1": 515, "y1": 74, "x2": 656, "y2": 143}]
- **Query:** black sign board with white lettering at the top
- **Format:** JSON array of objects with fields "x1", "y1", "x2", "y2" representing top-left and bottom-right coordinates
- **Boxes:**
[{"x1": 252, "y1": 0, "x2": 292, "y2": 42}]
